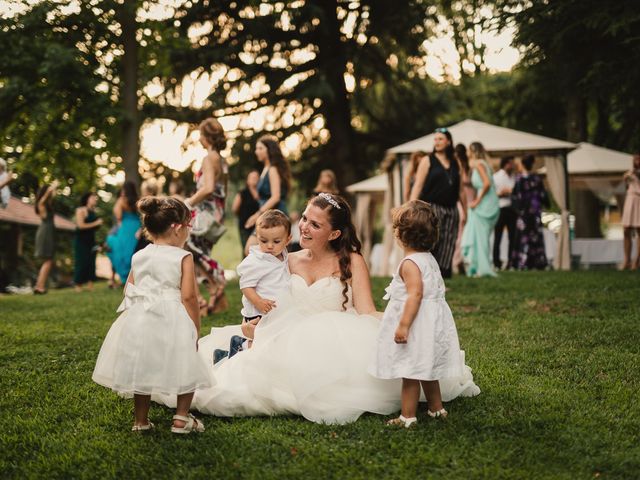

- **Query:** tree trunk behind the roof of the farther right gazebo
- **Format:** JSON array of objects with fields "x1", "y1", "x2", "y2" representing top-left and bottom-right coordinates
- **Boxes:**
[{"x1": 567, "y1": 92, "x2": 602, "y2": 238}]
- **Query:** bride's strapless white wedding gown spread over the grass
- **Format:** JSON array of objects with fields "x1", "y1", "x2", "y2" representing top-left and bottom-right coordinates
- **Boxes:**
[{"x1": 154, "y1": 274, "x2": 480, "y2": 424}]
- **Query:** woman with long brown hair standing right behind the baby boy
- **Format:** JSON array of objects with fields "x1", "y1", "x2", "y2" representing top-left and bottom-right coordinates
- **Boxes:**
[{"x1": 244, "y1": 135, "x2": 291, "y2": 254}]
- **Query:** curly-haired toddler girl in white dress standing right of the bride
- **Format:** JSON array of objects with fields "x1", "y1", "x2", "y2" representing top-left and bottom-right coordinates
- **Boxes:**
[{"x1": 369, "y1": 200, "x2": 470, "y2": 428}]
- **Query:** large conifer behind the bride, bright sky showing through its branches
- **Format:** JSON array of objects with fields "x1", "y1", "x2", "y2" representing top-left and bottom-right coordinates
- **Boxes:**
[{"x1": 144, "y1": 0, "x2": 436, "y2": 183}]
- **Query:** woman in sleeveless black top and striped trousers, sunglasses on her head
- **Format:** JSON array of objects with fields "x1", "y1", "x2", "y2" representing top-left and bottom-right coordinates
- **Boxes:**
[{"x1": 410, "y1": 128, "x2": 467, "y2": 278}]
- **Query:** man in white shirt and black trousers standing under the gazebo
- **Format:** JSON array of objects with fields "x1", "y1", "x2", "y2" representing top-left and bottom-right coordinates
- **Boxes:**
[{"x1": 493, "y1": 157, "x2": 518, "y2": 270}]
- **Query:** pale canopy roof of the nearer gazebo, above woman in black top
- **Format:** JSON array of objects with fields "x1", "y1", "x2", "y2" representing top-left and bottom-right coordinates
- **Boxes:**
[{"x1": 389, "y1": 119, "x2": 577, "y2": 156}]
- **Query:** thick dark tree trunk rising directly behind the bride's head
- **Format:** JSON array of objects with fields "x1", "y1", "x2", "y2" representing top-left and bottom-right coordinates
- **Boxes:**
[{"x1": 317, "y1": 0, "x2": 358, "y2": 187}]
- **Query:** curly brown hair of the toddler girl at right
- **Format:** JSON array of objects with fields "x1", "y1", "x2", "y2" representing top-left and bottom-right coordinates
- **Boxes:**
[{"x1": 391, "y1": 200, "x2": 440, "y2": 252}]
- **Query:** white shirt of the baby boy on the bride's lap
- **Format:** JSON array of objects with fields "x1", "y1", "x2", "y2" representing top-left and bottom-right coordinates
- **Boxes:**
[{"x1": 237, "y1": 246, "x2": 291, "y2": 317}]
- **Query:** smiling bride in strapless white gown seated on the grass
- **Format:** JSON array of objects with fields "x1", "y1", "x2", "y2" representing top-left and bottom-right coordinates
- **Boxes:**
[{"x1": 156, "y1": 194, "x2": 480, "y2": 424}]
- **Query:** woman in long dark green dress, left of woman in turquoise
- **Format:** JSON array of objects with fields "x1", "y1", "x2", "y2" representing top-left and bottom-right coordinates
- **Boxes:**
[{"x1": 73, "y1": 192, "x2": 102, "y2": 292}]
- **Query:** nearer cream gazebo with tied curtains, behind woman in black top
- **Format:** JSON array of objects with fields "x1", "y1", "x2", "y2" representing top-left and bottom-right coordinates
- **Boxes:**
[{"x1": 347, "y1": 119, "x2": 577, "y2": 275}]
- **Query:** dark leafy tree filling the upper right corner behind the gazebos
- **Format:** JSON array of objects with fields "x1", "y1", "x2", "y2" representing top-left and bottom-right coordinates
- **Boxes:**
[{"x1": 498, "y1": 0, "x2": 640, "y2": 237}]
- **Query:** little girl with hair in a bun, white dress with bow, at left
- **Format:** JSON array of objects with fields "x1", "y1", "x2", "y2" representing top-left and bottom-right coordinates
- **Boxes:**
[{"x1": 93, "y1": 197, "x2": 211, "y2": 433}]
